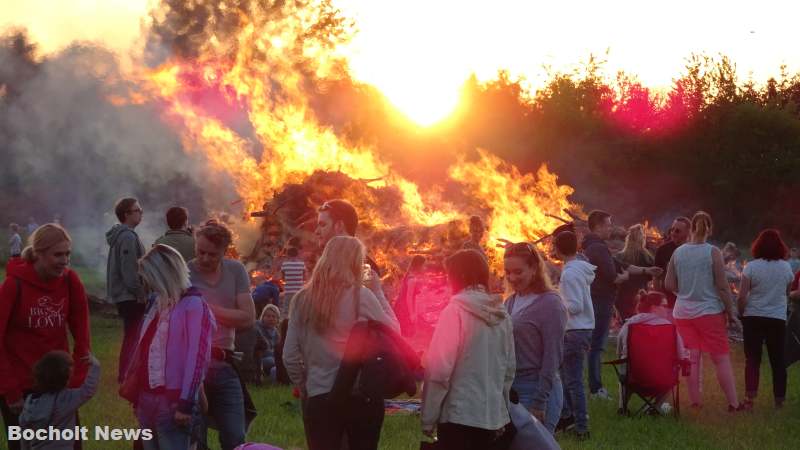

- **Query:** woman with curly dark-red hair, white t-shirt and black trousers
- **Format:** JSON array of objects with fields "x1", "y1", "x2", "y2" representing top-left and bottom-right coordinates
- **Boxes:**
[{"x1": 739, "y1": 229, "x2": 794, "y2": 408}]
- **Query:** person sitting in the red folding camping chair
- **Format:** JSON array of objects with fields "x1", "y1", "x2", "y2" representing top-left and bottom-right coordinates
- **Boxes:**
[{"x1": 617, "y1": 289, "x2": 687, "y2": 414}]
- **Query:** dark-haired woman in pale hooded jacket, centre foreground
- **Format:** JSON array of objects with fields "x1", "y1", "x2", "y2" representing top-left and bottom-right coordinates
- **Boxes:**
[{"x1": 422, "y1": 250, "x2": 516, "y2": 450}]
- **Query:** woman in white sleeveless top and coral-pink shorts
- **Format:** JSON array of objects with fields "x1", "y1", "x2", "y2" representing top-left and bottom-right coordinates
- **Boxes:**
[{"x1": 664, "y1": 211, "x2": 744, "y2": 412}]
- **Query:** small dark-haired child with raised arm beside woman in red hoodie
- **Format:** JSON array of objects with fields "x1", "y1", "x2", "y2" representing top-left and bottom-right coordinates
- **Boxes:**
[{"x1": 19, "y1": 350, "x2": 100, "y2": 449}]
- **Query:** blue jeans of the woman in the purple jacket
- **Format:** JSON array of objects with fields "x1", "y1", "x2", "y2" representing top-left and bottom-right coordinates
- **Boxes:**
[{"x1": 136, "y1": 391, "x2": 196, "y2": 450}]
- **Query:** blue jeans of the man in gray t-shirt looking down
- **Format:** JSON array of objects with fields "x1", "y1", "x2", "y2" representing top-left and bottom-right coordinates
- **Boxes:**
[{"x1": 202, "y1": 359, "x2": 247, "y2": 450}]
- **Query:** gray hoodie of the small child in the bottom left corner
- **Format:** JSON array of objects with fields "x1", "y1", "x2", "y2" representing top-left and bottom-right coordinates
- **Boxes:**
[{"x1": 19, "y1": 356, "x2": 100, "y2": 450}]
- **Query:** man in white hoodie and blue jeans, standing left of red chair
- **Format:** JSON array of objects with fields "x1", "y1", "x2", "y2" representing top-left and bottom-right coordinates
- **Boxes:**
[{"x1": 553, "y1": 231, "x2": 597, "y2": 439}]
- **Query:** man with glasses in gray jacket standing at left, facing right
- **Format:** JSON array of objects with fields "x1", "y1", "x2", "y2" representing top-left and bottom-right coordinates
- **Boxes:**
[{"x1": 106, "y1": 198, "x2": 145, "y2": 383}]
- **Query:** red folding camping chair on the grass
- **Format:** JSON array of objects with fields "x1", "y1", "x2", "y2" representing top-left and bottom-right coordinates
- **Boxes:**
[{"x1": 604, "y1": 324, "x2": 689, "y2": 418}]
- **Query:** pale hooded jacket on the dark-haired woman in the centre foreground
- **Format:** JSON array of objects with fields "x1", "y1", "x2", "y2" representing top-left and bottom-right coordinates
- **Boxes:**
[{"x1": 422, "y1": 290, "x2": 516, "y2": 430}]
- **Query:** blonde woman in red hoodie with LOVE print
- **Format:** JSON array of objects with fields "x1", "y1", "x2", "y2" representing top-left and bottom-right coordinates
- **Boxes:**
[{"x1": 0, "y1": 223, "x2": 90, "y2": 449}]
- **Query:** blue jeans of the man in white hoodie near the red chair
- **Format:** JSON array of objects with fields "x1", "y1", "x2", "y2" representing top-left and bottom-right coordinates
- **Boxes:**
[{"x1": 561, "y1": 330, "x2": 592, "y2": 433}]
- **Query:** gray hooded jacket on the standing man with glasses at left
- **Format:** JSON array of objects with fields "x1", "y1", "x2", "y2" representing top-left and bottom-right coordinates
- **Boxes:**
[{"x1": 106, "y1": 223, "x2": 145, "y2": 303}]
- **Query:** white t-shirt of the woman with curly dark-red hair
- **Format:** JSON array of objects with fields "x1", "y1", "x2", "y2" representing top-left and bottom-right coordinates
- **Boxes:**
[{"x1": 743, "y1": 259, "x2": 794, "y2": 320}]
